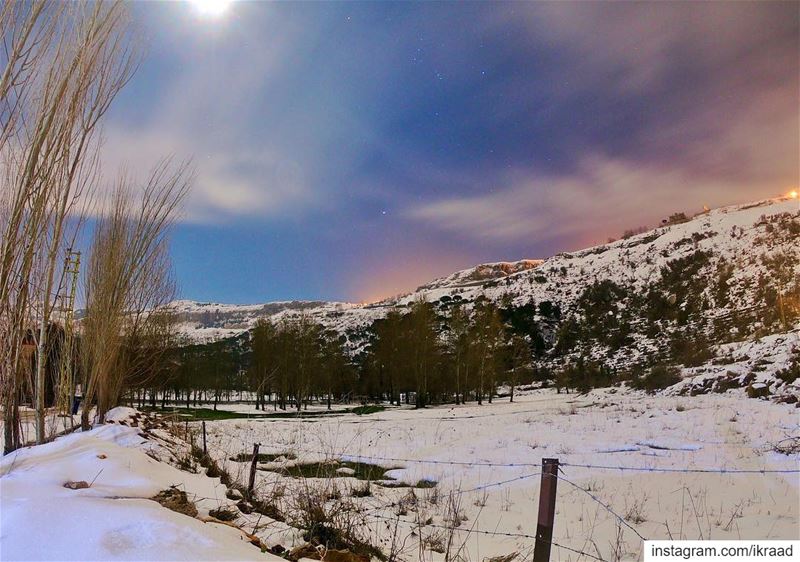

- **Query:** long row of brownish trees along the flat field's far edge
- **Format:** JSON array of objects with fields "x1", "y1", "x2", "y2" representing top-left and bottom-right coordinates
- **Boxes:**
[{"x1": 135, "y1": 297, "x2": 536, "y2": 411}]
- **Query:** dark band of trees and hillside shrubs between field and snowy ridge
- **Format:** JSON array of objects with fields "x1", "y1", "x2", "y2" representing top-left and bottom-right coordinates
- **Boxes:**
[{"x1": 128, "y1": 234, "x2": 800, "y2": 409}]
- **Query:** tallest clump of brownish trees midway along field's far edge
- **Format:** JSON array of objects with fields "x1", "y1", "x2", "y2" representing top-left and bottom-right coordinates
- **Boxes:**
[{"x1": 358, "y1": 298, "x2": 533, "y2": 407}]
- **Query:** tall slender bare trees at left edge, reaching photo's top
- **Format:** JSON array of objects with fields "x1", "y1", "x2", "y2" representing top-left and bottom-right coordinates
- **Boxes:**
[{"x1": 0, "y1": 2, "x2": 138, "y2": 450}]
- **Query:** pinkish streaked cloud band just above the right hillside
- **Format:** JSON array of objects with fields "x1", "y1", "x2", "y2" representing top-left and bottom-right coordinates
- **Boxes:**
[{"x1": 405, "y1": 89, "x2": 800, "y2": 246}]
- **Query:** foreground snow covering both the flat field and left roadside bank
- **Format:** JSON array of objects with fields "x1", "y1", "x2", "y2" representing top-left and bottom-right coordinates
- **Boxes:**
[{"x1": 0, "y1": 388, "x2": 800, "y2": 561}]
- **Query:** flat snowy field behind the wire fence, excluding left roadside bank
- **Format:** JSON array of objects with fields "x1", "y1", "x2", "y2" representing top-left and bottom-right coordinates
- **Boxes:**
[{"x1": 195, "y1": 389, "x2": 800, "y2": 561}]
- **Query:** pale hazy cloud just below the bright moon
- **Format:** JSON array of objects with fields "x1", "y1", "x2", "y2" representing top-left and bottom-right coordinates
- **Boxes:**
[{"x1": 97, "y1": 3, "x2": 362, "y2": 223}]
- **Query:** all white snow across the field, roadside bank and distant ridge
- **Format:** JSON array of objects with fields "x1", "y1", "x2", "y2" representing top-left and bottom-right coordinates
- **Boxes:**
[{"x1": 18, "y1": 199, "x2": 800, "y2": 562}]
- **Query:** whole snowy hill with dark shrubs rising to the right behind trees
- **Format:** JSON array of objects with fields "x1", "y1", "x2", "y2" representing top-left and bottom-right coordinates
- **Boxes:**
[{"x1": 175, "y1": 199, "x2": 800, "y2": 398}]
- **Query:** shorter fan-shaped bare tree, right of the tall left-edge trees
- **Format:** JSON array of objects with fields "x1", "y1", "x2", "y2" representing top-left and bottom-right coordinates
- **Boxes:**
[{"x1": 81, "y1": 160, "x2": 193, "y2": 428}]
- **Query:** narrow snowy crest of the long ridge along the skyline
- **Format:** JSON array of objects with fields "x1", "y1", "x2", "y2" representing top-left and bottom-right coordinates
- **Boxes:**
[{"x1": 173, "y1": 198, "x2": 798, "y2": 342}]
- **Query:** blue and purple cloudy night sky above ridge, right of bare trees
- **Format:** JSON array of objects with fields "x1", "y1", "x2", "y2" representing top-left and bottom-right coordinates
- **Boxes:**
[{"x1": 103, "y1": 0, "x2": 800, "y2": 303}]
